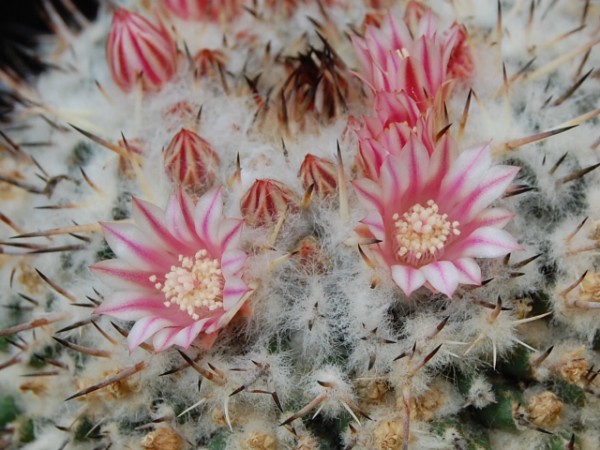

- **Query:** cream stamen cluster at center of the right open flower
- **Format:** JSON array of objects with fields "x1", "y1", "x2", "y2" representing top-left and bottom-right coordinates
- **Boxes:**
[{"x1": 392, "y1": 200, "x2": 460, "y2": 261}]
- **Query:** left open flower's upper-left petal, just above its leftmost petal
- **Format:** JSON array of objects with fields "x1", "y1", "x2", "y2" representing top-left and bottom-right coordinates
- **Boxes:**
[{"x1": 101, "y1": 223, "x2": 177, "y2": 272}]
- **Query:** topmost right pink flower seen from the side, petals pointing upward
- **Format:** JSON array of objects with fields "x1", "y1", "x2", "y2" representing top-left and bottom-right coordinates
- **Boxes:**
[{"x1": 354, "y1": 12, "x2": 472, "y2": 111}]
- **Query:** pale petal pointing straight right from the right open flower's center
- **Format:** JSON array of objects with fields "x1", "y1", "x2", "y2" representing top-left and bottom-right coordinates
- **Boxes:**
[{"x1": 446, "y1": 227, "x2": 521, "y2": 258}]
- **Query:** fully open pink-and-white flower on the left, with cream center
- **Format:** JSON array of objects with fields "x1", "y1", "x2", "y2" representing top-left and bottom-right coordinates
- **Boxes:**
[{"x1": 92, "y1": 188, "x2": 250, "y2": 351}]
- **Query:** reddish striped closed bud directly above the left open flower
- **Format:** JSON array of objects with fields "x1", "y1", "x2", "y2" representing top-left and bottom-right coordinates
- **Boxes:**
[{"x1": 164, "y1": 128, "x2": 220, "y2": 195}]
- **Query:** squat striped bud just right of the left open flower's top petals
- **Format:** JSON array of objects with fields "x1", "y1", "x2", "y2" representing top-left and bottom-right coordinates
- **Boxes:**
[{"x1": 240, "y1": 179, "x2": 297, "y2": 227}]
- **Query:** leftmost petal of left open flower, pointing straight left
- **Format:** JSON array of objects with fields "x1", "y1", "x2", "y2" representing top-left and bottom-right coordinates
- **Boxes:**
[{"x1": 90, "y1": 259, "x2": 156, "y2": 292}]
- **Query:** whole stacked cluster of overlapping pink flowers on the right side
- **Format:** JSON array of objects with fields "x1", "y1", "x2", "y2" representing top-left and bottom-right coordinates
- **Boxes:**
[{"x1": 354, "y1": 2, "x2": 519, "y2": 297}]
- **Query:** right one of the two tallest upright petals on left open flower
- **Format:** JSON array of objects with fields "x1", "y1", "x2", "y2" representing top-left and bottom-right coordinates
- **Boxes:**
[{"x1": 194, "y1": 187, "x2": 223, "y2": 255}]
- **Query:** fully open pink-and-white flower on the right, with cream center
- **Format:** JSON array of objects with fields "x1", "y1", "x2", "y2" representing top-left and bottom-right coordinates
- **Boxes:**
[{"x1": 354, "y1": 135, "x2": 520, "y2": 297}]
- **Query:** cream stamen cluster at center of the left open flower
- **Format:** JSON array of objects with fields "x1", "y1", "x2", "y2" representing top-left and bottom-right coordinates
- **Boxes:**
[{"x1": 150, "y1": 250, "x2": 223, "y2": 320}]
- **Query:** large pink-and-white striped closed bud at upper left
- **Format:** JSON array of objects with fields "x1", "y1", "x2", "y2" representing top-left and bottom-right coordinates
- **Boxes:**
[{"x1": 106, "y1": 8, "x2": 177, "y2": 92}]
